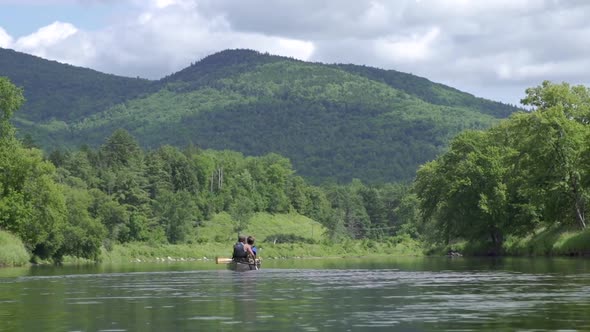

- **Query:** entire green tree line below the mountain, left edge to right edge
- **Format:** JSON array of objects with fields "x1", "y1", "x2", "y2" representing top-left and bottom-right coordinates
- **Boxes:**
[{"x1": 0, "y1": 78, "x2": 590, "y2": 262}]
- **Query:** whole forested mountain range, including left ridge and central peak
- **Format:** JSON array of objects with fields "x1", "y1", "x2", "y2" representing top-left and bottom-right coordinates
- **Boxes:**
[{"x1": 0, "y1": 50, "x2": 517, "y2": 183}]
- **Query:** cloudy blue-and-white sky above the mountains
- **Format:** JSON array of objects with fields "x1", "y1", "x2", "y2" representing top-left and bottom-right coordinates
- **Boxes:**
[{"x1": 0, "y1": 0, "x2": 590, "y2": 104}]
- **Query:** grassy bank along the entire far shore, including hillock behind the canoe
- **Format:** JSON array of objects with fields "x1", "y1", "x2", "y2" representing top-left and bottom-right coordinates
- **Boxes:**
[{"x1": 8, "y1": 213, "x2": 590, "y2": 266}]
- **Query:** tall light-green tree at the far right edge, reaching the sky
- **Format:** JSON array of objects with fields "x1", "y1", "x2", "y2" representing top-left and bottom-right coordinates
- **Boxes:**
[{"x1": 512, "y1": 81, "x2": 590, "y2": 229}]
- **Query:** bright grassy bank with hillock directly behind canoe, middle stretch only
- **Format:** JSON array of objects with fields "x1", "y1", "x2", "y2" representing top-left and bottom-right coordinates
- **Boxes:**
[{"x1": 101, "y1": 213, "x2": 423, "y2": 263}]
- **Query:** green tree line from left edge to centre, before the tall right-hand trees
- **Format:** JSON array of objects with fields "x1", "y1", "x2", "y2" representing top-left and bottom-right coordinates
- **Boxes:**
[{"x1": 0, "y1": 78, "x2": 418, "y2": 262}]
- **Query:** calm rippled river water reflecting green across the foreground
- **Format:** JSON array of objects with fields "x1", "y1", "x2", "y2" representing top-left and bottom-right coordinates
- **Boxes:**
[{"x1": 0, "y1": 258, "x2": 590, "y2": 331}]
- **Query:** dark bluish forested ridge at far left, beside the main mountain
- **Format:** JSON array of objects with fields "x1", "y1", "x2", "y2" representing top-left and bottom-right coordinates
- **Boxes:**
[{"x1": 0, "y1": 48, "x2": 155, "y2": 122}]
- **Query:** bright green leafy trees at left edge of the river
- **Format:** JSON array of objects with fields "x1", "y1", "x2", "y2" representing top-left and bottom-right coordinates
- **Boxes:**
[{"x1": 0, "y1": 79, "x2": 110, "y2": 262}]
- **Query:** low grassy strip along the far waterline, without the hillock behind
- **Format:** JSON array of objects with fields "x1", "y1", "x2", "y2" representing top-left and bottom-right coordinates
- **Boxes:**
[{"x1": 6, "y1": 223, "x2": 590, "y2": 266}]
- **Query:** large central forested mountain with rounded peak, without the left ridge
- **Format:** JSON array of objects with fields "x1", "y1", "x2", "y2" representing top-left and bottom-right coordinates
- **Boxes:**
[{"x1": 62, "y1": 55, "x2": 502, "y2": 183}]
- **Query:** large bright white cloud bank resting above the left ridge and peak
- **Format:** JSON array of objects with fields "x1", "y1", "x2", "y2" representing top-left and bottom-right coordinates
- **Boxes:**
[{"x1": 0, "y1": 0, "x2": 314, "y2": 78}]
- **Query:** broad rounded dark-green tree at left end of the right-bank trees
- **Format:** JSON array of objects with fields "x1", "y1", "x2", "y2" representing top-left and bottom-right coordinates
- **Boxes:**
[{"x1": 415, "y1": 131, "x2": 536, "y2": 253}]
